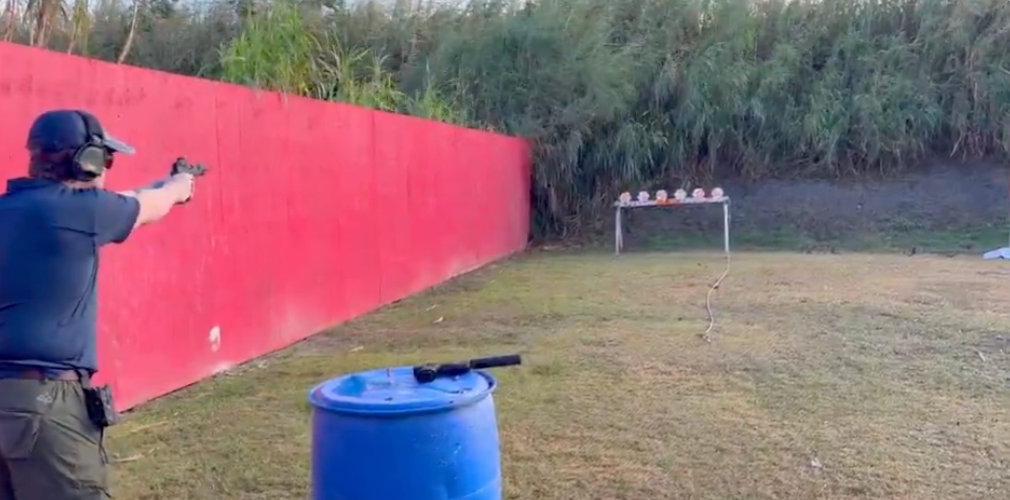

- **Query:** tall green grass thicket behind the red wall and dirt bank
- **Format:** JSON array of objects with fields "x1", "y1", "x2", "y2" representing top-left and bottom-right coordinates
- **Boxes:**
[{"x1": 0, "y1": 0, "x2": 1010, "y2": 235}]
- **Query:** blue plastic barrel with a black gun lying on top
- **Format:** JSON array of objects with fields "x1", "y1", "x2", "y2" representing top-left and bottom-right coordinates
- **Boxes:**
[{"x1": 309, "y1": 368, "x2": 502, "y2": 500}]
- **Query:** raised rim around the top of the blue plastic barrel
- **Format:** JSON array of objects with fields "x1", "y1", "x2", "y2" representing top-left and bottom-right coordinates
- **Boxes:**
[{"x1": 308, "y1": 367, "x2": 498, "y2": 416}]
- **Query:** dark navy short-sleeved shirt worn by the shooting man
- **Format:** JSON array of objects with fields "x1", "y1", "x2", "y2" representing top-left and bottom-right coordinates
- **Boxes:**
[{"x1": 0, "y1": 178, "x2": 140, "y2": 376}]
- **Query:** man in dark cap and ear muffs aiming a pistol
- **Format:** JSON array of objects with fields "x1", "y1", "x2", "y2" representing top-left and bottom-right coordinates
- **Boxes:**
[{"x1": 0, "y1": 110, "x2": 204, "y2": 500}]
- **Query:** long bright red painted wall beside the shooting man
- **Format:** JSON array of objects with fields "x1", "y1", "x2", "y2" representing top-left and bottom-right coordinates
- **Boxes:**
[{"x1": 0, "y1": 43, "x2": 530, "y2": 408}]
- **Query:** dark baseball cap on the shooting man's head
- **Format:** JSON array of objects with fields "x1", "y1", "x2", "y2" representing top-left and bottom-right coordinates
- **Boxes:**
[{"x1": 27, "y1": 109, "x2": 135, "y2": 155}]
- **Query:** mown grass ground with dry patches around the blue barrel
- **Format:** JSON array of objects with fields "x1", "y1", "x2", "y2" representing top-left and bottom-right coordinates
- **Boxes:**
[{"x1": 110, "y1": 253, "x2": 1010, "y2": 500}]
